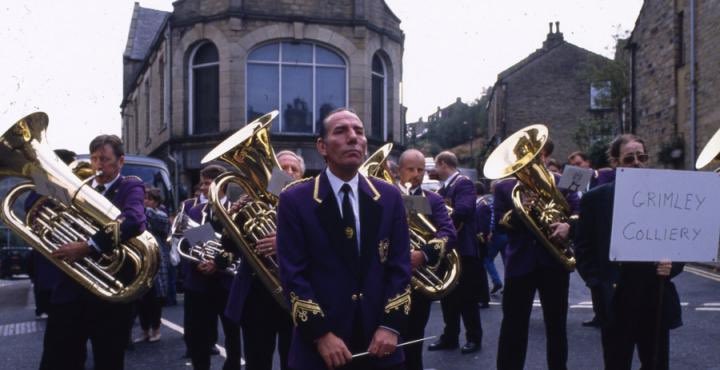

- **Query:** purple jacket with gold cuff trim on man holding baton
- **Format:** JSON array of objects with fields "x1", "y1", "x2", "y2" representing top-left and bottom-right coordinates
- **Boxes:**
[{"x1": 277, "y1": 172, "x2": 410, "y2": 370}]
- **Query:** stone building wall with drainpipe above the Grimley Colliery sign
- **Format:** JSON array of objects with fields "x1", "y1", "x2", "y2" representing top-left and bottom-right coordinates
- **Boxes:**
[{"x1": 627, "y1": 0, "x2": 720, "y2": 169}]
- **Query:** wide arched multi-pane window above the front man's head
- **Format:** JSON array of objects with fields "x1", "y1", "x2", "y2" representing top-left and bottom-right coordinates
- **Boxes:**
[{"x1": 246, "y1": 41, "x2": 347, "y2": 134}]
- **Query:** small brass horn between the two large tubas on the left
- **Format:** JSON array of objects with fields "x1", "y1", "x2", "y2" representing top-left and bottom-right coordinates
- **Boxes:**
[{"x1": 170, "y1": 209, "x2": 240, "y2": 275}]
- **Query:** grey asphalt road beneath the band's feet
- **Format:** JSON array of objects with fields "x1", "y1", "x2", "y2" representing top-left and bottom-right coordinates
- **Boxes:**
[{"x1": 0, "y1": 267, "x2": 720, "y2": 369}]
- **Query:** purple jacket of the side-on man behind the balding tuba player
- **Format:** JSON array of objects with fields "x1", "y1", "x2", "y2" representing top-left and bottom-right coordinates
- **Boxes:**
[{"x1": 438, "y1": 174, "x2": 480, "y2": 257}]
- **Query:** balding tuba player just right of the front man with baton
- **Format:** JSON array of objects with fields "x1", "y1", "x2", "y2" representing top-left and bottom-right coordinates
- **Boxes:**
[{"x1": 398, "y1": 149, "x2": 456, "y2": 370}]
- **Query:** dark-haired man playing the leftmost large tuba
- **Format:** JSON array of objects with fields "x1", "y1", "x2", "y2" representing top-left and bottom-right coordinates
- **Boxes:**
[{"x1": 40, "y1": 135, "x2": 145, "y2": 369}]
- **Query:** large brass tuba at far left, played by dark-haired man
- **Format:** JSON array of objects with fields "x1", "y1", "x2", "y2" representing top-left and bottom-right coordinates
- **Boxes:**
[{"x1": 0, "y1": 112, "x2": 160, "y2": 302}]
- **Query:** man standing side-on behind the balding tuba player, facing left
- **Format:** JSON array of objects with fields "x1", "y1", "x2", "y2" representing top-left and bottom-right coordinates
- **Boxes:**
[{"x1": 428, "y1": 152, "x2": 487, "y2": 354}]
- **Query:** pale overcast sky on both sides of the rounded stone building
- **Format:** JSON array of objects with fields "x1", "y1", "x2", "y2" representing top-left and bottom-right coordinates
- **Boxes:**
[{"x1": 0, "y1": 0, "x2": 642, "y2": 153}]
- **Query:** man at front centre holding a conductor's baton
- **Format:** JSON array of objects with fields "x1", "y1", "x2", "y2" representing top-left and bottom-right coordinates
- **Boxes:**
[{"x1": 277, "y1": 109, "x2": 411, "y2": 370}]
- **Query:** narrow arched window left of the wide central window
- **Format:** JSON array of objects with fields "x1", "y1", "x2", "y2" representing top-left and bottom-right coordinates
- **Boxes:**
[{"x1": 188, "y1": 42, "x2": 220, "y2": 135}]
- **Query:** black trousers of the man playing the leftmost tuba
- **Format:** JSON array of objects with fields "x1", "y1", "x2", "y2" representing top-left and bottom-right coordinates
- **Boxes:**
[{"x1": 40, "y1": 292, "x2": 131, "y2": 370}]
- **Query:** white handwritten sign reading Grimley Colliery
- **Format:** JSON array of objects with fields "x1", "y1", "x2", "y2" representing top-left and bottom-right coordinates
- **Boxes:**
[{"x1": 610, "y1": 168, "x2": 720, "y2": 262}]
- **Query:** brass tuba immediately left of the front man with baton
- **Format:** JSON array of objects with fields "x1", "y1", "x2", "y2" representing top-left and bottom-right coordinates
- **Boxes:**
[{"x1": 201, "y1": 111, "x2": 289, "y2": 311}]
